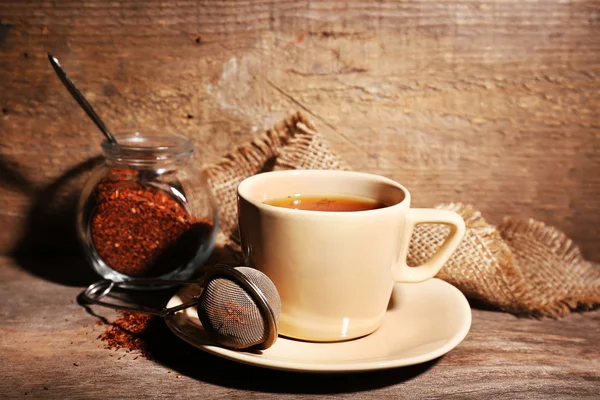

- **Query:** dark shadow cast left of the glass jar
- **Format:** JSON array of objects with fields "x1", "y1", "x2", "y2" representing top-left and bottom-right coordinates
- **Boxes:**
[{"x1": 0, "y1": 155, "x2": 101, "y2": 286}]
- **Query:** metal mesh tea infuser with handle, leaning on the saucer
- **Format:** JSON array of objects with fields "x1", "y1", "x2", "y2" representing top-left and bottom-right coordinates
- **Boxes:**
[{"x1": 83, "y1": 266, "x2": 281, "y2": 350}]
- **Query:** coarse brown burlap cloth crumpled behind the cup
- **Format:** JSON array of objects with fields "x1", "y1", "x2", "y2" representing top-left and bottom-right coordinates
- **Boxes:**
[{"x1": 206, "y1": 113, "x2": 600, "y2": 318}]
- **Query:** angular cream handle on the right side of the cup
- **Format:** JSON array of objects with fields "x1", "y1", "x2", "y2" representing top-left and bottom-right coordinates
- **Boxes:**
[{"x1": 394, "y1": 208, "x2": 465, "y2": 282}]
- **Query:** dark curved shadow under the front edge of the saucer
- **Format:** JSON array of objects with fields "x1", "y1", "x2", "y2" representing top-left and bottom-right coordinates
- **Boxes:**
[{"x1": 143, "y1": 319, "x2": 438, "y2": 394}]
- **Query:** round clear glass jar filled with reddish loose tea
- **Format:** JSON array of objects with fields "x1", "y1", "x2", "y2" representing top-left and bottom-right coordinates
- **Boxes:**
[{"x1": 77, "y1": 133, "x2": 218, "y2": 282}]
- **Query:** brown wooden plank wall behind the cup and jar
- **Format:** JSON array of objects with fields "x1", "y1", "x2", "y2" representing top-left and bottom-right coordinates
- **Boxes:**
[{"x1": 0, "y1": 0, "x2": 600, "y2": 261}]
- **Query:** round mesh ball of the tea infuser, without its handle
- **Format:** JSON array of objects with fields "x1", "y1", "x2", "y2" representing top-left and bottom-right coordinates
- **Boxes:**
[{"x1": 198, "y1": 267, "x2": 281, "y2": 349}]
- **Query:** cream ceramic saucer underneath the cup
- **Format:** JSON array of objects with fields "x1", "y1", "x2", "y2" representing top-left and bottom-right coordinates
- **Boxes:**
[{"x1": 165, "y1": 278, "x2": 471, "y2": 372}]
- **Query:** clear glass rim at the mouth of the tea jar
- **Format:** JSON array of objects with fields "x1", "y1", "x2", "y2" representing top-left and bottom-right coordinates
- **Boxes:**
[{"x1": 102, "y1": 132, "x2": 194, "y2": 161}]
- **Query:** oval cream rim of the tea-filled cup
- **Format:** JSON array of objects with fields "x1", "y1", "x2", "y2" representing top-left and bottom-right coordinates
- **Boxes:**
[{"x1": 237, "y1": 169, "x2": 411, "y2": 216}]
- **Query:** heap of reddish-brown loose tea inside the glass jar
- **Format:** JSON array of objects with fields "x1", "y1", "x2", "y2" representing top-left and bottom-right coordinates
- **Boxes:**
[{"x1": 90, "y1": 169, "x2": 213, "y2": 277}]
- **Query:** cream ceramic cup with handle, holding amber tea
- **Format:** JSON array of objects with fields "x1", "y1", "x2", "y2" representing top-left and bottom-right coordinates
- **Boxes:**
[{"x1": 238, "y1": 170, "x2": 465, "y2": 342}]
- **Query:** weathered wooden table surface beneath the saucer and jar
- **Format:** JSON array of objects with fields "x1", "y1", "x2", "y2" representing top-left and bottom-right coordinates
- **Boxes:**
[{"x1": 0, "y1": 257, "x2": 600, "y2": 399}]
